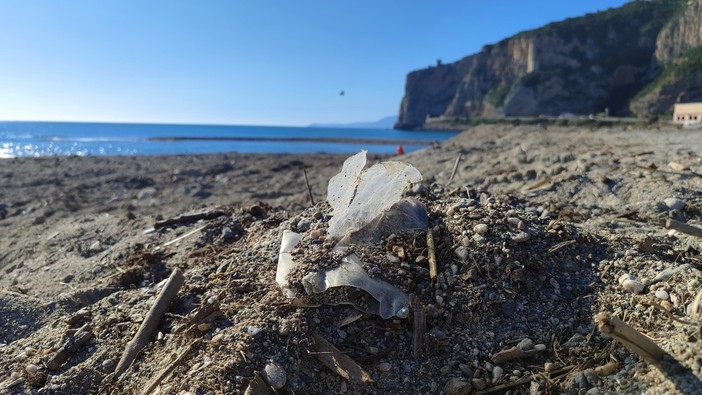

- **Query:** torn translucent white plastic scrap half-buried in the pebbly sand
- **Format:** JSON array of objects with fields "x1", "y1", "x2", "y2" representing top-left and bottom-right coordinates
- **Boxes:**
[{"x1": 276, "y1": 151, "x2": 429, "y2": 319}]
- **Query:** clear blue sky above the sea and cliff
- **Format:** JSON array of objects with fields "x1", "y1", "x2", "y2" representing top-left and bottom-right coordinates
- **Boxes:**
[{"x1": 0, "y1": 0, "x2": 627, "y2": 125}]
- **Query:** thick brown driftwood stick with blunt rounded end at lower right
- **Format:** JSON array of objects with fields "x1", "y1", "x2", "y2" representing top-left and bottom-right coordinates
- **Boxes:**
[{"x1": 597, "y1": 313, "x2": 666, "y2": 366}]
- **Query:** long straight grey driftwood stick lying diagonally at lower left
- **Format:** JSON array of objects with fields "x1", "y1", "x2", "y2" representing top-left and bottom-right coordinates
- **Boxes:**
[{"x1": 115, "y1": 269, "x2": 185, "y2": 377}]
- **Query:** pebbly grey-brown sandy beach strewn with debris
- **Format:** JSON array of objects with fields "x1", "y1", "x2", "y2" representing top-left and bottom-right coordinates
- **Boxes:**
[{"x1": 0, "y1": 125, "x2": 702, "y2": 394}]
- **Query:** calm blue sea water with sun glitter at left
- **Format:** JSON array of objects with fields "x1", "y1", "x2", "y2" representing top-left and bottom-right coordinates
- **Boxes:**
[{"x1": 0, "y1": 122, "x2": 456, "y2": 158}]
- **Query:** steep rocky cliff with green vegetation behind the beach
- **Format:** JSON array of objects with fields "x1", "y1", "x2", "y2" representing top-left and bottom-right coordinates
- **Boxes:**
[{"x1": 396, "y1": 0, "x2": 702, "y2": 129}]
